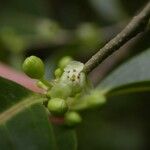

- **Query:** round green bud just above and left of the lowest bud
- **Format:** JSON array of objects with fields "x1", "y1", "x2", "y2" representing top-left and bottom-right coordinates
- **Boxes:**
[{"x1": 47, "y1": 98, "x2": 68, "y2": 116}]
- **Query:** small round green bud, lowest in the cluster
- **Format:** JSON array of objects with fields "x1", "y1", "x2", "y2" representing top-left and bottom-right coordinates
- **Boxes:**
[{"x1": 64, "y1": 111, "x2": 82, "y2": 127}]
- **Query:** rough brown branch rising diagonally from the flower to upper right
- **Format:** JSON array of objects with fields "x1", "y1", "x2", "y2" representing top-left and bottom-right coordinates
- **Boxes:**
[{"x1": 84, "y1": 2, "x2": 150, "y2": 73}]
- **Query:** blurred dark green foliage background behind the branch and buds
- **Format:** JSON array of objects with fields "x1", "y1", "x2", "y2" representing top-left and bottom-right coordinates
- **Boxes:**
[{"x1": 0, "y1": 0, "x2": 150, "y2": 150}]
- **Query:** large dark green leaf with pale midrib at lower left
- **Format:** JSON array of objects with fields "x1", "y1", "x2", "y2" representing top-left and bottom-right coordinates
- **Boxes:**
[{"x1": 0, "y1": 78, "x2": 76, "y2": 150}]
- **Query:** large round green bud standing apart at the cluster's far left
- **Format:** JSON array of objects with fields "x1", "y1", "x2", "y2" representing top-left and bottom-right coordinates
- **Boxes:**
[{"x1": 22, "y1": 56, "x2": 44, "y2": 79}]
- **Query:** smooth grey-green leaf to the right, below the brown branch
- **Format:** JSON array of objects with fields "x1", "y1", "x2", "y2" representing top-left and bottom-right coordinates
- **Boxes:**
[{"x1": 99, "y1": 49, "x2": 150, "y2": 93}]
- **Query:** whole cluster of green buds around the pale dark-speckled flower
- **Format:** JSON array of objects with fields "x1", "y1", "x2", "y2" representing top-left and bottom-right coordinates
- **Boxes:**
[{"x1": 23, "y1": 56, "x2": 106, "y2": 127}]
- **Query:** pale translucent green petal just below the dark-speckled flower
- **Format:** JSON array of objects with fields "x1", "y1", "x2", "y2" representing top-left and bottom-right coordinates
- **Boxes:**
[{"x1": 49, "y1": 82, "x2": 72, "y2": 99}]
